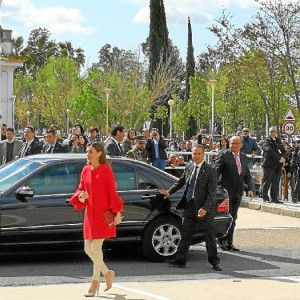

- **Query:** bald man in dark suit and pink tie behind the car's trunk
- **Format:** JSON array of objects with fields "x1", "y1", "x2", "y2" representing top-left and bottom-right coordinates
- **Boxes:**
[{"x1": 215, "y1": 136, "x2": 253, "y2": 251}]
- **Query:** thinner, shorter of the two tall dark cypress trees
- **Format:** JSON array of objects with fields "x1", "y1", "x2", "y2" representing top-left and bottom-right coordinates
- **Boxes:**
[{"x1": 185, "y1": 17, "x2": 197, "y2": 137}]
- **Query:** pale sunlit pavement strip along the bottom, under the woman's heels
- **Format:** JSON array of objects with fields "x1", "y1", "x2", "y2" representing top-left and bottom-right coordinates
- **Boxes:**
[{"x1": 0, "y1": 276, "x2": 300, "y2": 300}]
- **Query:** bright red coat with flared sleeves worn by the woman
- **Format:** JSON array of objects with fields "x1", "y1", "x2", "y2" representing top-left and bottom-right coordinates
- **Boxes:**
[{"x1": 70, "y1": 165, "x2": 124, "y2": 240}]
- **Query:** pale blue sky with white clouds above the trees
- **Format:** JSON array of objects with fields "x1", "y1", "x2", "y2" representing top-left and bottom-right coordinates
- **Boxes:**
[{"x1": 0, "y1": 0, "x2": 296, "y2": 65}]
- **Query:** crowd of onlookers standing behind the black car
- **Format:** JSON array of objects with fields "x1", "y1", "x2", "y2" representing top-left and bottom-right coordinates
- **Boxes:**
[{"x1": 0, "y1": 124, "x2": 300, "y2": 203}]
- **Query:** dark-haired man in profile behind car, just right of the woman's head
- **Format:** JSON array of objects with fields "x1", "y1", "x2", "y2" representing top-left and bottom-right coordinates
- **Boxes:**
[{"x1": 104, "y1": 125, "x2": 126, "y2": 156}]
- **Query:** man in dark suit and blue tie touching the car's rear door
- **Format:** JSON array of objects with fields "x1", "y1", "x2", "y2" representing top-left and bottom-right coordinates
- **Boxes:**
[{"x1": 160, "y1": 145, "x2": 222, "y2": 271}]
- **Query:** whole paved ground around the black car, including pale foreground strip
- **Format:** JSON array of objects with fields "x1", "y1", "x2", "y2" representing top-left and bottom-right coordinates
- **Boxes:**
[{"x1": 0, "y1": 208, "x2": 300, "y2": 300}]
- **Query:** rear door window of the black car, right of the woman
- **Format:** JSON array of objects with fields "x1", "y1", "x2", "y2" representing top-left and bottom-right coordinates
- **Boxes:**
[{"x1": 112, "y1": 164, "x2": 136, "y2": 191}]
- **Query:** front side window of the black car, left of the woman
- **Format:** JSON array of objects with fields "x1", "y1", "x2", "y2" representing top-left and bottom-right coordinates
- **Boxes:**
[{"x1": 28, "y1": 165, "x2": 82, "y2": 195}]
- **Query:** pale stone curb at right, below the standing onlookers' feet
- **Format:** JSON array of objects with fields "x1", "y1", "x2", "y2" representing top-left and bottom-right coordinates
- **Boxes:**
[{"x1": 241, "y1": 197, "x2": 300, "y2": 218}]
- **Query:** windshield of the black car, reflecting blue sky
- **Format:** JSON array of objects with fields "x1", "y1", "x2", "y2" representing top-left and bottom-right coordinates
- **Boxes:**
[{"x1": 0, "y1": 159, "x2": 41, "y2": 192}]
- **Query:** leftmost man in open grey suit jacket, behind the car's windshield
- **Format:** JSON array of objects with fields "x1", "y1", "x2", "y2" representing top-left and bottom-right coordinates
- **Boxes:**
[{"x1": 0, "y1": 127, "x2": 22, "y2": 165}]
